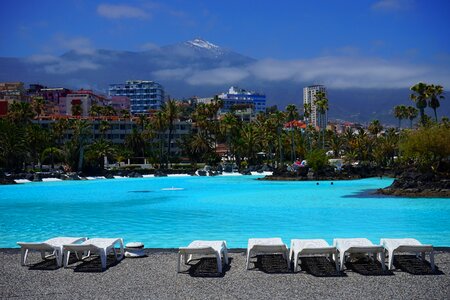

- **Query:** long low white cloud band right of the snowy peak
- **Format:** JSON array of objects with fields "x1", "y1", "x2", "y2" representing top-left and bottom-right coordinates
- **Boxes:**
[{"x1": 153, "y1": 56, "x2": 450, "y2": 89}]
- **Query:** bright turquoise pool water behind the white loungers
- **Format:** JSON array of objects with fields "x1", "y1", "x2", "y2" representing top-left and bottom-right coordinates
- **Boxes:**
[{"x1": 0, "y1": 176, "x2": 450, "y2": 248}]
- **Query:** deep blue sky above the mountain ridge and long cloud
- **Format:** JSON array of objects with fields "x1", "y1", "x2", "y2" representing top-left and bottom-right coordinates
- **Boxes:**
[{"x1": 0, "y1": 0, "x2": 450, "y2": 60}]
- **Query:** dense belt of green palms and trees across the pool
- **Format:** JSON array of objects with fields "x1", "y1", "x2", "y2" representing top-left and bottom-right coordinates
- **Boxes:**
[{"x1": 0, "y1": 83, "x2": 450, "y2": 178}]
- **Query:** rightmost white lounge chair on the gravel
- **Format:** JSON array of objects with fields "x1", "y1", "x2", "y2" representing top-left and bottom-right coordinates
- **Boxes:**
[{"x1": 380, "y1": 238, "x2": 435, "y2": 272}]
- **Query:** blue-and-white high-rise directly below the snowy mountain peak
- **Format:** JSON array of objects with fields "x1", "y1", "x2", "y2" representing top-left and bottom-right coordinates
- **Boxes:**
[{"x1": 219, "y1": 86, "x2": 266, "y2": 114}]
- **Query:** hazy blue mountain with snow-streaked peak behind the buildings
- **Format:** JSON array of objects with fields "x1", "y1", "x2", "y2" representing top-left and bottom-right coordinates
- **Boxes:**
[{"x1": 0, "y1": 39, "x2": 450, "y2": 124}]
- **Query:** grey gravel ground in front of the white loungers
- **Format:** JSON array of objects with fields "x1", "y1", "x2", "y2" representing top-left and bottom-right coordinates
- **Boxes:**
[{"x1": 0, "y1": 248, "x2": 450, "y2": 299}]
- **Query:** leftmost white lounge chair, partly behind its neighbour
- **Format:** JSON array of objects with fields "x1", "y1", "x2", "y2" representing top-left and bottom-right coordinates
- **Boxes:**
[{"x1": 17, "y1": 237, "x2": 87, "y2": 267}]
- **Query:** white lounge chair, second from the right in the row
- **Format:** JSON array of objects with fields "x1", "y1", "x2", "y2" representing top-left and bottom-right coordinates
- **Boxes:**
[{"x1": 333, "y1": 238, "x2": 386, "y2": 271}]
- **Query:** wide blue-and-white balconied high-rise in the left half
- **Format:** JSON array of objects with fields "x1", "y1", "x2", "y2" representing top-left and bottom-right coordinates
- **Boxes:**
[{"x1": 109, "y1": 80, "x2": 164, "y2": 115}]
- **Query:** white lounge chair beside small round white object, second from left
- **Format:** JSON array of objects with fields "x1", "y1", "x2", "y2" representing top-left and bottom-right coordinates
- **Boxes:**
[{"x1": 63, "y1": 238, "x2": 124, "y2": 270}]
